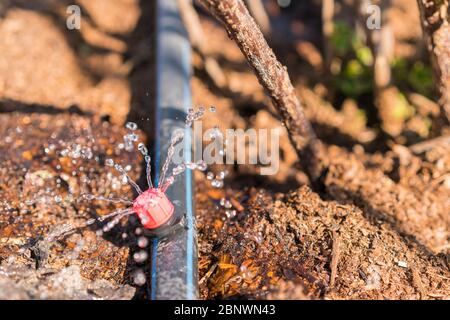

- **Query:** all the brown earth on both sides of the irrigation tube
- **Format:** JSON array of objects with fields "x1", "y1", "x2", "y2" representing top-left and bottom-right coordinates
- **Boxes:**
[{"x1": 0, "y1": 0, "x2": 450, "y2": 299}]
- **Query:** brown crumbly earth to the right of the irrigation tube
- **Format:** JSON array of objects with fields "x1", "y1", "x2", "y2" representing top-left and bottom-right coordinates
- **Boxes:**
[{"x1": 192, "y1": 2, "x2": 450, "y2": 299}]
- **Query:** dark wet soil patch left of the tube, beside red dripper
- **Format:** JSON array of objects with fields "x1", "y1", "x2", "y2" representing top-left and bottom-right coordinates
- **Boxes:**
[{"x1": 0, "y1": 114, "x2": 144, "y2": 298}]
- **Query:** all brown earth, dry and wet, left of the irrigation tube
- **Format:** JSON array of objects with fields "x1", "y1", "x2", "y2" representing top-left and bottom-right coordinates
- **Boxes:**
[{"x1": 0, "y1": 0, "x2": 153, "y2": 299}]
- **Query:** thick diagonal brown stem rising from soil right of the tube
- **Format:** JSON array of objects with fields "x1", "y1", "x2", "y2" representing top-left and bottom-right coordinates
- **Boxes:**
[{"x1": 199, "y1": 0, "x2": 325, "y2": 186}]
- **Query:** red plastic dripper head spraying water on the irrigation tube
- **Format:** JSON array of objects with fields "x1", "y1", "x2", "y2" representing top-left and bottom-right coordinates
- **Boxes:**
[{"x1": 133, "y1": 188, "x2": 175, "y2": 229}]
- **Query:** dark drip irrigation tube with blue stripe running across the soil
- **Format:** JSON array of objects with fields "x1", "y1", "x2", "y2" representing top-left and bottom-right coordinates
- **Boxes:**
[{"x1": 150, "y1": 0, "x2": 198, "y2": 300}]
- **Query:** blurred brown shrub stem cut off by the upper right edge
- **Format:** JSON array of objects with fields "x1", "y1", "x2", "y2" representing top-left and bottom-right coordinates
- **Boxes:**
[{"x1": 417, "y1": 0, "x2": 450, "y2": 121}]
